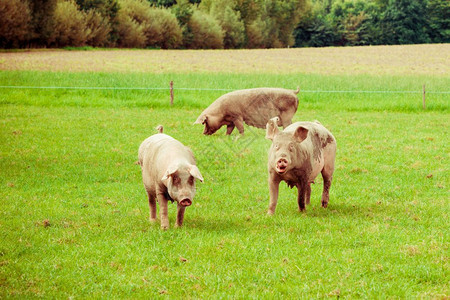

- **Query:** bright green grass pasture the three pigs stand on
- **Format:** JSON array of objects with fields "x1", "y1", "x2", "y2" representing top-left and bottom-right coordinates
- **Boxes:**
[{"x1": 0, "y1": 48, "x2": 450, "y2": 299}]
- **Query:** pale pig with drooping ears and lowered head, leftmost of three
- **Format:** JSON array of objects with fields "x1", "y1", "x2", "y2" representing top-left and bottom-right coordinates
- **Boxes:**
[{"x1": 138, "y1": 125, "x2": 203, "y2": 230}]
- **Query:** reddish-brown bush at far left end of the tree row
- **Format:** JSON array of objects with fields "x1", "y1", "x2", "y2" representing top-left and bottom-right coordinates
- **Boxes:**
[{"x1": 0, "y1": 0, "x2": 31, "y2": 48}]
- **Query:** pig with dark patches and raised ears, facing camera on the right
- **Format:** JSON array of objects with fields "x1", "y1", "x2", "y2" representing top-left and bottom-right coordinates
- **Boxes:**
[{"x1": 266, "y1": 118, "x2": 336, "y2": 215}]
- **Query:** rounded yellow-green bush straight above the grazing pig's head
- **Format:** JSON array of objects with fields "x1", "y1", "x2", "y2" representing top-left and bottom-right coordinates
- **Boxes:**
[{"x1": 185, "y1": 10, "x2": 223, "y2": 49}]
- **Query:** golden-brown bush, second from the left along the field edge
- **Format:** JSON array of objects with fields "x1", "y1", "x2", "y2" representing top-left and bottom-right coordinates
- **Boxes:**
[{"x1": 50, "y1": 0, "x2": 88, "y2": 47}]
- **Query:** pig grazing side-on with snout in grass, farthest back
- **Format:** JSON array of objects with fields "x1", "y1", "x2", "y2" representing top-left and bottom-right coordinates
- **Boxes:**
[{"x1": 194, "y1": 87, "x2": 300, "y2": 135}]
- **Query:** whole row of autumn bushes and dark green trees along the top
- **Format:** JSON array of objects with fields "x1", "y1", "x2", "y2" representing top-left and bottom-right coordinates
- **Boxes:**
[{"x1": 0, "y1": 0, "x2": 450, "y2": 49}]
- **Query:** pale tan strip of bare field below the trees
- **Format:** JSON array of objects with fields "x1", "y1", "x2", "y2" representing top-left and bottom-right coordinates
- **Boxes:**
[{"x1": 0, "y1": 44, "x2": 450, "y2": 76}]
